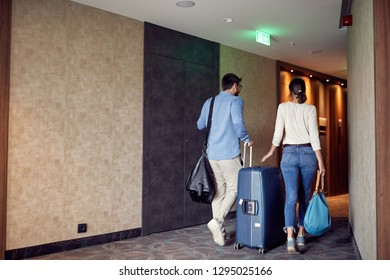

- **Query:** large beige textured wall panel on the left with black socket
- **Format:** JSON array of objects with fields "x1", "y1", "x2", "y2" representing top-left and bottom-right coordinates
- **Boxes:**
[{"x1": 6, "y1": 0, "x2": 143, "y2": 250}]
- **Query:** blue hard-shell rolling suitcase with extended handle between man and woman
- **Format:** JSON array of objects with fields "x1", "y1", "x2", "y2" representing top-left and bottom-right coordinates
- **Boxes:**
[{"x1": 234, "y1": 147, "x2": 286, "y2": 254}]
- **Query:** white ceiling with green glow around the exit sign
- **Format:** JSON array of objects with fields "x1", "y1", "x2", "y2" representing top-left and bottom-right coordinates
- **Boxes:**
[{"x1": 70, "y1": 0, "x2": 347, "y2": 79}]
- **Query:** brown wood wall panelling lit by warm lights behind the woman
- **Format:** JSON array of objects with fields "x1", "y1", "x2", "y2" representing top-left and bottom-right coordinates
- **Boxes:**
[{"x1": 277, "y1": 66, "x2": 348, "y2": 196}]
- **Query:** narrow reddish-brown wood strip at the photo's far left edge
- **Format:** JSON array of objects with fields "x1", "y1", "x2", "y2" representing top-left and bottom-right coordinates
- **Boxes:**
[{"x1": 0, "y1": 0, "x2": 12, "y2": 259}]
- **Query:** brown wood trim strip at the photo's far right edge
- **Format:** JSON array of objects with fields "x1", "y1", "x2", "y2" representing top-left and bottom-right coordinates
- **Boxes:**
[{"x1": 374, "y1": 0, "x2": 390, "y2": 259}]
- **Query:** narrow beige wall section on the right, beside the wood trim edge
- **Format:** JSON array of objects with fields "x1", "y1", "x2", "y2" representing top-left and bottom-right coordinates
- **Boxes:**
[{"x1": 348, "y1": 0, "x2": 377, "y2": 260}]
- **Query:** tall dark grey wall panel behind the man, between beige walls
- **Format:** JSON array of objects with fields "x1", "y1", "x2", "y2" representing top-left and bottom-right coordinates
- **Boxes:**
[{"x1": 142, "y1": 23, "x2": 219, "y2": 235}]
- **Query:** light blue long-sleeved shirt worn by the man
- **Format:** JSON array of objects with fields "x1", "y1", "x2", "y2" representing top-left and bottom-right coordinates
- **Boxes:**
[{"x1": 197, "y1": 91, "x2": 250, "y2": 160}]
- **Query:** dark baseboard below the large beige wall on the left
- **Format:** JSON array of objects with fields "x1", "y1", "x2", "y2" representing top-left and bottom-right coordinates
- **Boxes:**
[{"x1": 5, "y1": 228, "x2": 141, "y2": 260}]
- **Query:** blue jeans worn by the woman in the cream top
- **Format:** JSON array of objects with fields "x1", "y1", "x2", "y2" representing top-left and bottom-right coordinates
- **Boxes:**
[{"x1": 280, "y1": 146, "x2": 317, "y2": 232}]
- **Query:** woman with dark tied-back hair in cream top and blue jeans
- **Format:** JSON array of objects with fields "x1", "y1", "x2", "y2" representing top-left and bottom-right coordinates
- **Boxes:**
[{"x1": 261, "y1": 78, "x2": 325, "y2": 254}]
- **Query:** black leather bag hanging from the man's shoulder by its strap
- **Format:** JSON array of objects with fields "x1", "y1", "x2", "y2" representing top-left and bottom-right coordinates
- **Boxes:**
[{"x1": 186, "y1": 97, "x2": 216, "y2": 203}]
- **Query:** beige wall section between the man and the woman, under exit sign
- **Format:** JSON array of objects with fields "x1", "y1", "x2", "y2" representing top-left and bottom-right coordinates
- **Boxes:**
[{"x1": 220, "y1": 45, "x2": 279, "y2": 165}]
